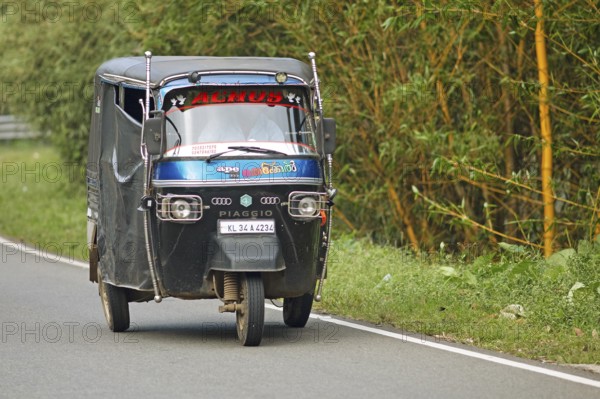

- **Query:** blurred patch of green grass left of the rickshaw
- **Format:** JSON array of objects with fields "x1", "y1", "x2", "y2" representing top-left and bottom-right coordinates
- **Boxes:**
[{"x1": 0, "y1": 141, "x2": 86, "y2": 257}]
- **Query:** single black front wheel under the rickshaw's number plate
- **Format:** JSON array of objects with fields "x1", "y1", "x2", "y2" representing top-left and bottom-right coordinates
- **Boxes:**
[{"x1": 236, "y1": 273, "x2": 265, "y2": 346}]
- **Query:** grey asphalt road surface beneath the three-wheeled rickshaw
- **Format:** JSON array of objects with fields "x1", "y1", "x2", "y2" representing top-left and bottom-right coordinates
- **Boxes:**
[{"x1": 0, "y1": 244, "x2": 600, "y2": 399}]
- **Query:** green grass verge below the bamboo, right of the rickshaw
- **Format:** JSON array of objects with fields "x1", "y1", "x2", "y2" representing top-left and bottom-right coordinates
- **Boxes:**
[{"x1": 322, "y1": 237, "x2": 600, "y2": 364}]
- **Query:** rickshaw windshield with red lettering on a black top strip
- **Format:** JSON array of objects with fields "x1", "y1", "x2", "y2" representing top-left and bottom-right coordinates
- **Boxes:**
[{"x1": 163, "y1": 86, "x2": 316, "y2": 156}]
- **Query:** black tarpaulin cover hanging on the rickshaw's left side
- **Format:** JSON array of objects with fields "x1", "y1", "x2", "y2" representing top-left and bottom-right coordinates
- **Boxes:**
[{"x1": 92, "y1": 83, "x2": 152, "y2": 290}]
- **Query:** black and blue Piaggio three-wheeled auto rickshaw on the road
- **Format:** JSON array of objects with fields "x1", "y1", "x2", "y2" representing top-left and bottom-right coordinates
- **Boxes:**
[{"x1": 87, "y1": 52, "x2": 336, "y2": 346}]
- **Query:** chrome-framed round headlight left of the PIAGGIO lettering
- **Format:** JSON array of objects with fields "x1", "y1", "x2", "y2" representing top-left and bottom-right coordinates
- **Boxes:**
[{"x1": 156, "y1": 194, "x2": 204, "y2": 223}]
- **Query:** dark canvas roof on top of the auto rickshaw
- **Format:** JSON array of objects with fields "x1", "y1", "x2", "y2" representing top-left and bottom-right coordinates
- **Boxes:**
[{"x1": 96, "y1": 56, "x2": 312, "y2": 87}]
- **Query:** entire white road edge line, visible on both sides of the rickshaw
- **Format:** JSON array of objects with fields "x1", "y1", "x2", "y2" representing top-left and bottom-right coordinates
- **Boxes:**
[{"x1": 0, "y1": 237, "x2": 600, "y2": 388}]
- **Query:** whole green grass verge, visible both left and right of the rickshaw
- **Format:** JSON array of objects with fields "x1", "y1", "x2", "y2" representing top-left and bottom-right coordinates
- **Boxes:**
[{"x1": 0, "y1": 142, "x2": 600, "y2": 363}]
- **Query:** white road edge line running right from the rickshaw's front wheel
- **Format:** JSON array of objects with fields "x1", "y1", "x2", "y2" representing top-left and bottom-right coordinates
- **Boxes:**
[{"x1": 265, "y1": 303, "x2": 600, "y2": 388}]
